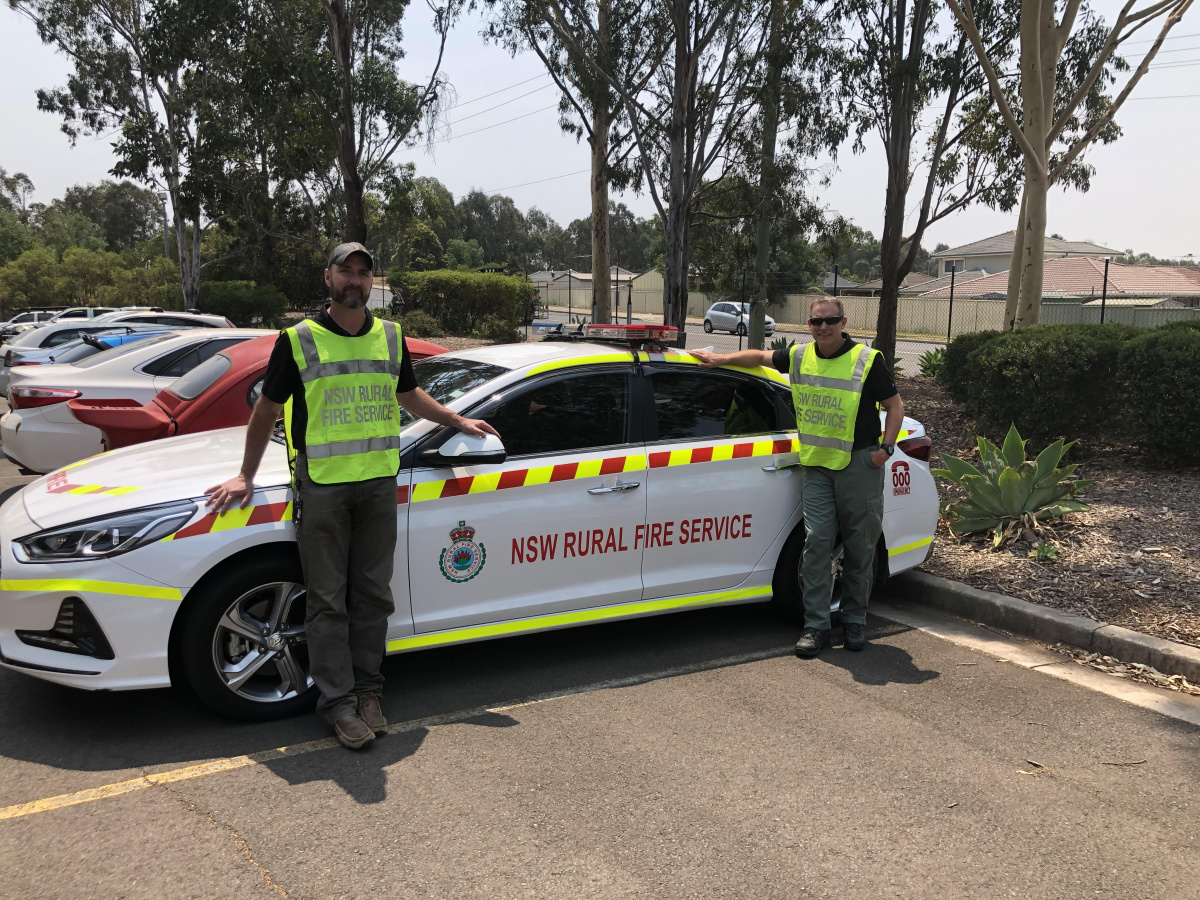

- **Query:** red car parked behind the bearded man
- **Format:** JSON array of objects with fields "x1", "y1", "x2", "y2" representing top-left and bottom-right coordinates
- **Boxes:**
[{"x1": 67, "y1": 335, "x2": 446, "y2": 450}]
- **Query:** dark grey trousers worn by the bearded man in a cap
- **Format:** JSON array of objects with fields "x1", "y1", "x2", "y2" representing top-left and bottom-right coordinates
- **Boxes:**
[{"x1": 293, "y1": 456, "x2": 396, "y2": 724}]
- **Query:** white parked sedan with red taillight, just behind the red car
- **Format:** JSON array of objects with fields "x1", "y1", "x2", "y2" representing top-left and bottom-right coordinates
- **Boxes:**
[{"x1": 0, "y1": 325, "x2": 271, "y2": 472}]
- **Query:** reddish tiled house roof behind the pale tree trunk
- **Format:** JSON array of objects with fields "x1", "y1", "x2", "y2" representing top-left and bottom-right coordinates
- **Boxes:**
[{"x1": 922, "y1": 257, "x2": 1200, "y2": 299}]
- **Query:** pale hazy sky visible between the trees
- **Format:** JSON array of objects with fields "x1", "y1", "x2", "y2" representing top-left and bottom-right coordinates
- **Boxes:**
[{"x1": 0, "y1": 0, "x2": 1200, "y2": 258}]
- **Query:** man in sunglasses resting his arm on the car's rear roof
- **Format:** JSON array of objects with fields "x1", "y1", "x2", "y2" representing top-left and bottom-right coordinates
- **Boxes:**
[{"x1": 691, "y1": 298, "x2": 904, "y2": 659}]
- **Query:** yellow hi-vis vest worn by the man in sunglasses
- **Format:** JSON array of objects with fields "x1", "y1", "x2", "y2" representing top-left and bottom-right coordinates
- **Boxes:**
[{"x1": 788, "y1": 342, "x2": 880, "y2": 469}]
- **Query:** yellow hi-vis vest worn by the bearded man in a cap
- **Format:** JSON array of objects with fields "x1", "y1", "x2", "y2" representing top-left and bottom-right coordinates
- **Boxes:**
[{"x1": 283, "y1": 318, "x2": 403, "y2": 485}]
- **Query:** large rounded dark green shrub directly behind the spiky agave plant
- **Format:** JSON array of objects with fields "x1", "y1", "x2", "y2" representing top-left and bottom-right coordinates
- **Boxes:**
[{"x1": 945, "y1": 325, "x2": 1139, "y2": 444}]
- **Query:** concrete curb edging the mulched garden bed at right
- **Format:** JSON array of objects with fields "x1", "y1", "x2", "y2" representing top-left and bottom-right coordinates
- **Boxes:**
[{"x1": 888, "y1": 571, "x2": 1200, "y2": 684}]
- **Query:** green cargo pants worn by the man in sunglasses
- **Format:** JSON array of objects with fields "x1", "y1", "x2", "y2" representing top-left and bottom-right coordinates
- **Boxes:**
[{"x1": 800, "y1": 448, "x2": 884, "y2": 629}]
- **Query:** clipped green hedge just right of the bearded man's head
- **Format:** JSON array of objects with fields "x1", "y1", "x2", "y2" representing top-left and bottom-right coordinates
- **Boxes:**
[{"x1": 388, "y1": 269, "x2": 533, "y2": 340}]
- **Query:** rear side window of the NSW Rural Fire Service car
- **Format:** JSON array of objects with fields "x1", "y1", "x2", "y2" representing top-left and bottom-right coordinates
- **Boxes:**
[{"x1": 650, "y1": 371, "x2": 791, "y2": 440}]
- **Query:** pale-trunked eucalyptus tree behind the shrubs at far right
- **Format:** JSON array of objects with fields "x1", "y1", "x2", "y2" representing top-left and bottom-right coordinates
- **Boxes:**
[{"x1": 946, "y1": 0, "x2": 1192, "y2": 329}]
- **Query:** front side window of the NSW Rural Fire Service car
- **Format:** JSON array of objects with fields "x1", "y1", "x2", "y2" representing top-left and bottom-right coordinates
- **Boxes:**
[{"x1": 482, "y1": 372, "x2": 630, "y2": 456}]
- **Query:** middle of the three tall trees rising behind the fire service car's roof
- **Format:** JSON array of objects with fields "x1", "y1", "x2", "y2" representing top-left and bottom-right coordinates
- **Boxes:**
[{"x1": 545, "y1": 0, "x2": 767, "y2": 340}]
